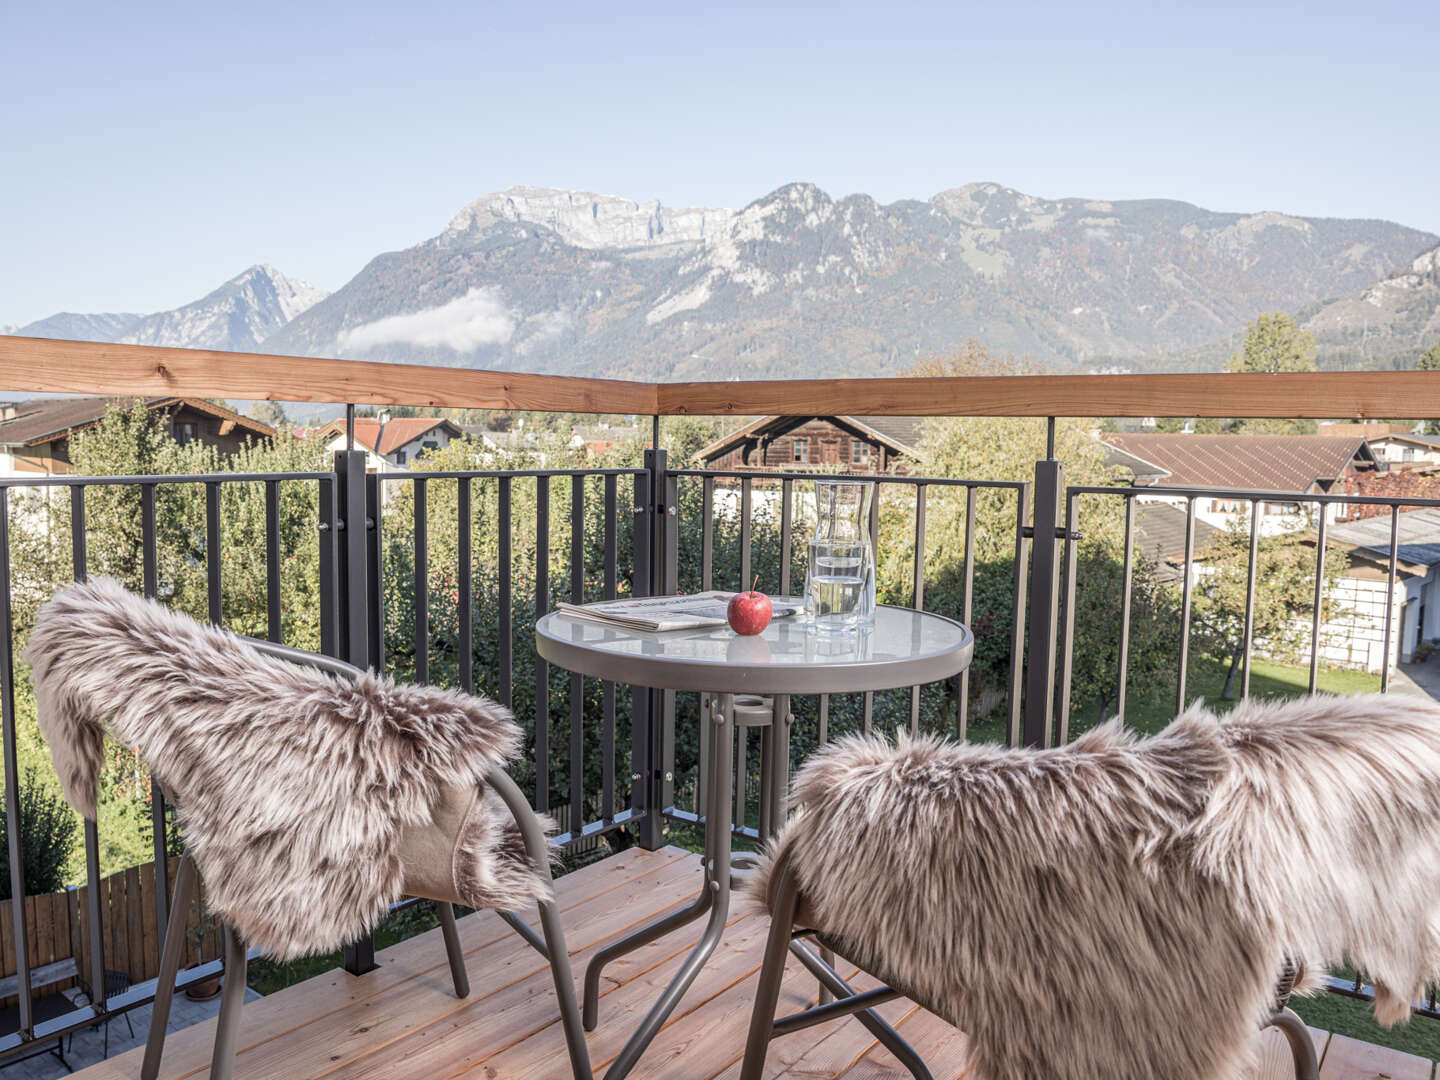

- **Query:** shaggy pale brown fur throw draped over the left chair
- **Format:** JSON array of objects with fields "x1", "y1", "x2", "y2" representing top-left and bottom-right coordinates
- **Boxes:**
[{"x1": 27, "y1": 577, "x2": 547, "y2": 959}]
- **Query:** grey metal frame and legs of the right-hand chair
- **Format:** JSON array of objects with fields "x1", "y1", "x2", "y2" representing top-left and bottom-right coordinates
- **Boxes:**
[{"x1": 740, "y1": 854, "x2": 1319, "y2": 1080}]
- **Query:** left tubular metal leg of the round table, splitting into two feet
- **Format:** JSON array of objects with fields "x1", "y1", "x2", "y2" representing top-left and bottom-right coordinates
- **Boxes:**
[{"x1": 599, "y1": 694, "x2": 734, "y2": 1080}]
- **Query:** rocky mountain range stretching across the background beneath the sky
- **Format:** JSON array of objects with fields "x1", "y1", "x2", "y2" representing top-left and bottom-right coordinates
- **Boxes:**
[{"x1": 5, "y1": 183, "x2": 1440, "y2": 379}]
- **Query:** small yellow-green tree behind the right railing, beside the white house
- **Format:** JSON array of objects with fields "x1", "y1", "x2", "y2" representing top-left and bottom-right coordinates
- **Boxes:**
[{"x1": 1194, "y1": 514, "x2": 1349, "y2": 700}]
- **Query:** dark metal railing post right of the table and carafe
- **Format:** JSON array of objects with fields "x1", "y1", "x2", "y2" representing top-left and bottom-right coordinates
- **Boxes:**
[{"x1": 1015, "y1": 420, "x2": 1066, "y2": 746}]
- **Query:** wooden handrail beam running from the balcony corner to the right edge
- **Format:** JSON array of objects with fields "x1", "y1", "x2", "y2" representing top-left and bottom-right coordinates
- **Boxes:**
[{"x1": 658, "y1": 372, "x2": 1440, "y2": 419}]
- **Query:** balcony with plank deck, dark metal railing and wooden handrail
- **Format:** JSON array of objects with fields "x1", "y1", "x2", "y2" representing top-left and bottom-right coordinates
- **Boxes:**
[{"x1": 0, "y1": 338, "x2": 1440, "y2": 1079}]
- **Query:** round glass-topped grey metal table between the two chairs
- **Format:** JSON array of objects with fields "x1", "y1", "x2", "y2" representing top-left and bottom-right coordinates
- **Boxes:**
[{"x1": 536, "y1": 605, "x2": 975, "y2": 1080}]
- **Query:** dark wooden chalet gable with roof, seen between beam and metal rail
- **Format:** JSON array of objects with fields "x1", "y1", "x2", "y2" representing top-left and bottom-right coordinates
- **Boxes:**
[{"x1": 696, "y1": 416, "x2": 923, "y2": 474}]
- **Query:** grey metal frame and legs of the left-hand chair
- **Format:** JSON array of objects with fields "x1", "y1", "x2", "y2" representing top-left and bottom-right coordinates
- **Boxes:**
[{"x1": 140, "y1": 638, "x2": 592, "y2": 1080}]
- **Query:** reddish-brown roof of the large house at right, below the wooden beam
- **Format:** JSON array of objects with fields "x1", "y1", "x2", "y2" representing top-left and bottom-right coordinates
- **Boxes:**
[{"x1": 1100, "y1": 433, "x2": 1374, "y2": 491}]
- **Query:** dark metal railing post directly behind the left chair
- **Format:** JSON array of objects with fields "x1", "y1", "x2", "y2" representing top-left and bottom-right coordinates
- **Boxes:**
[{"x1": 321, "y1": 449, "x2": 382, "y2": 975}]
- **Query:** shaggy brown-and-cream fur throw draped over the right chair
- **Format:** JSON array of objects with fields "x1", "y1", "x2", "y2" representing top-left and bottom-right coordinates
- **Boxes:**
[{"x1": 752, "y1": 694, "x2": 1440, "y2": 1080}]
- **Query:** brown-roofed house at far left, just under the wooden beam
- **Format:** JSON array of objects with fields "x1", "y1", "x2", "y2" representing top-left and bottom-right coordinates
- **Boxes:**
[{"x1": 0, "y1": 396, "x2": 275, "y2": 477}]
